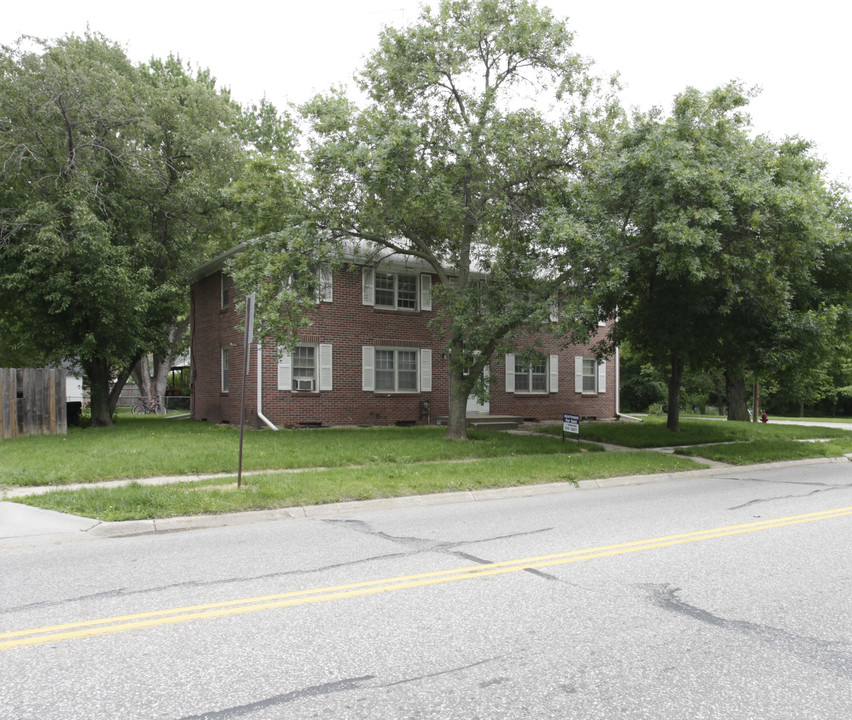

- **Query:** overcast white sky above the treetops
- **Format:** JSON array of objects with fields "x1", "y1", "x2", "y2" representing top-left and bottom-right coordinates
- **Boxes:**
[{"x1": 6, "y1": 0, "x2": 852, "y2": 182}]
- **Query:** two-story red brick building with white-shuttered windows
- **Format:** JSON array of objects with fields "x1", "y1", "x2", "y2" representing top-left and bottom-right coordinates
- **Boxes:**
[{"x1": 191, "y1": 248, "x2": 618, "y2": 426}]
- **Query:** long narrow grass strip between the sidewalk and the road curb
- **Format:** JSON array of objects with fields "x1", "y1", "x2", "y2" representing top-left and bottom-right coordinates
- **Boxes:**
[{"x1": 17, "y1": 451, "x2": 704, "y2": 521}]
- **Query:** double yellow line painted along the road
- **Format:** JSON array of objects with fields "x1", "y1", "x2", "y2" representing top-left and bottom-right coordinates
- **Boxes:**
[{"x1": 0, "y1": 507, "x2": 852, "y2": 650}]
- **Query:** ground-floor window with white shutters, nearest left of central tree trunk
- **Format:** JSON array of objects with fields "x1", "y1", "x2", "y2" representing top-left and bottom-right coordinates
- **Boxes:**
[{"x1": 361, "y1": 345, "x2": 432, "y2": 393}]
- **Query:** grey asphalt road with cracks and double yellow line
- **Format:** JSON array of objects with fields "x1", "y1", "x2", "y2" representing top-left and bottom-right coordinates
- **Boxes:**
[{"x1": 0, "y1": 463, "x2": 852, "y2": 720}]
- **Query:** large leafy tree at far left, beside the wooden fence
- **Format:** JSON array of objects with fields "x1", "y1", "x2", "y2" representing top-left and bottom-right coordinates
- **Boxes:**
[{"x1": 0, "y1": 34, "x2": 248, "y2": 425}]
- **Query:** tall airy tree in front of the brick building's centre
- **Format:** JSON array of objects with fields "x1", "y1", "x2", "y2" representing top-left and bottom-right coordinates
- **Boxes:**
[{"x1": 240, "y1": 0, "x2": 614, "y2": 438}]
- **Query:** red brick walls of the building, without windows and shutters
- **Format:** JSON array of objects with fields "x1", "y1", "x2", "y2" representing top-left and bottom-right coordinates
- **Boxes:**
[{"x1": 192, "y1": 271, "x2": 616, "y2": 426}]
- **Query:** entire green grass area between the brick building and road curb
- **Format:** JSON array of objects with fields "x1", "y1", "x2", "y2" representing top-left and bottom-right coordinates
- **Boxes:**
[{"x1": 8, "y1": 416, "x2": 852, "y2": 521}]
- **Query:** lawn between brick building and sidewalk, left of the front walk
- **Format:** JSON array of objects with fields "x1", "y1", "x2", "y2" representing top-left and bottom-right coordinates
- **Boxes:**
[{"x1": 0, "y1": 416, "x2": 600, "y2": 486}]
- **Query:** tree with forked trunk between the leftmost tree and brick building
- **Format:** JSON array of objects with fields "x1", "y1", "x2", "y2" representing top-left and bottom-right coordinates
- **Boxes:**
[{"x1": 127, "y1": 56, "x2": 246, "y2": 410}]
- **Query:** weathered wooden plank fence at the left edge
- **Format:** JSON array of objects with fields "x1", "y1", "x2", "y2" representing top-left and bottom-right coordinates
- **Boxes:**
[{"x1": 0, "y1": 368, "x2": 68, "y2": 439}]
